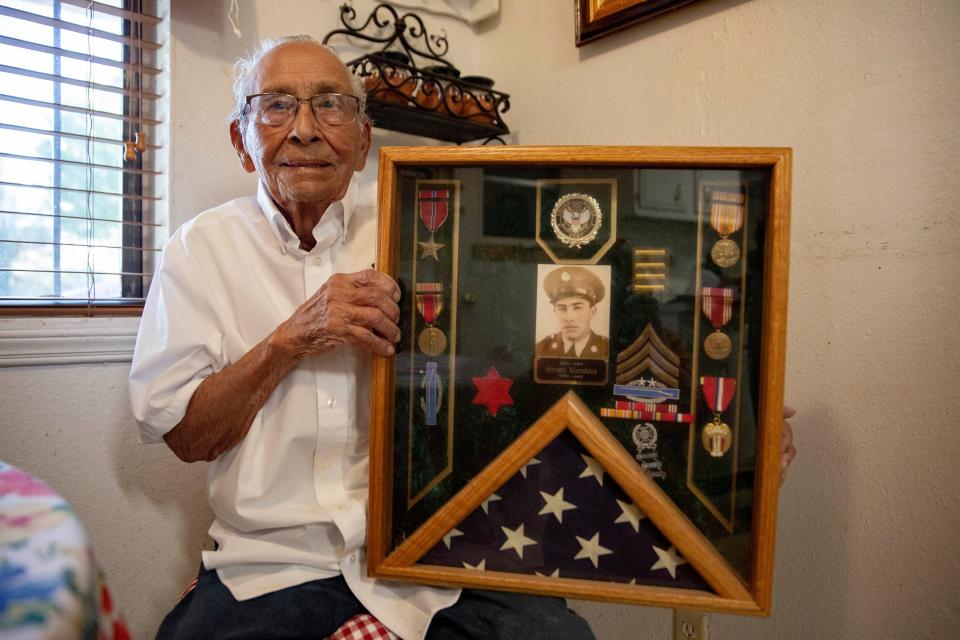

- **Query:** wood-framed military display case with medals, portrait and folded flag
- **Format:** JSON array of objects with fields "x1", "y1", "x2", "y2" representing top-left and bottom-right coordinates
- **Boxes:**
[{"x1": 368, "y1": 146, "x2": 791, "y2": 615}]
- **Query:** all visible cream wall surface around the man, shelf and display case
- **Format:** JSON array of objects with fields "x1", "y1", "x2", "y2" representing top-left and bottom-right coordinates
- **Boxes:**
[{"x1": 0, "y1": 0, "x2": 960, "y2": 640}]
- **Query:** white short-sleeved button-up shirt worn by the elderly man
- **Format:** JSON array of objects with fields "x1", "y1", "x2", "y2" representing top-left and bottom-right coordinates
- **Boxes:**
[{"x1": 130, "y1": 181, "x2": 459, "y2": 639}]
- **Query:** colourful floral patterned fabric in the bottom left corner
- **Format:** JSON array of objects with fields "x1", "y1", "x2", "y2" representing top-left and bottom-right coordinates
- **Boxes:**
[{"x1": 0, "y1": 462, "x2": 130, "y2": 640}]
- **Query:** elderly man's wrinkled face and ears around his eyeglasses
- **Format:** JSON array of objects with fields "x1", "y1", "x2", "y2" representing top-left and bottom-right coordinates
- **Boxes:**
[{"x1": 231, "y1": 43, "x2": 370, "y2": 210}]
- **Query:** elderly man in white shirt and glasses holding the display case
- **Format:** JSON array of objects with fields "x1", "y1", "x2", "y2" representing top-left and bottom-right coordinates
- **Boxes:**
[{"x1": 130, "y1": 36, "x2": 592, "y2": 639}]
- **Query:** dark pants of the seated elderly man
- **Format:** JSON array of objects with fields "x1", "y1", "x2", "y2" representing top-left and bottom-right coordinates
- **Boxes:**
[{"x1": 157, "y1": 568, "x2": 594, "y2": 640}]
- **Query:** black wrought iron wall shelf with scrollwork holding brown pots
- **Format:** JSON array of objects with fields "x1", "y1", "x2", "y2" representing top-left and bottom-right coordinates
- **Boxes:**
[{"x1": 323, "y1": 4, "x2": 510, "y2": 144}]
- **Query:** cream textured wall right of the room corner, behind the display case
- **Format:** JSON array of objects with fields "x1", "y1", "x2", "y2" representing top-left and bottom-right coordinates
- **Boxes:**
[{"x1": 480, "y1": 0, "x2": 960, "y2": 640}]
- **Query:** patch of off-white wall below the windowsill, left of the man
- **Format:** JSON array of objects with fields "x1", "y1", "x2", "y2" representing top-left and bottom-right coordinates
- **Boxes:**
[{"x1": 0, "y1": 340, "x2": 210, "y2": 638}]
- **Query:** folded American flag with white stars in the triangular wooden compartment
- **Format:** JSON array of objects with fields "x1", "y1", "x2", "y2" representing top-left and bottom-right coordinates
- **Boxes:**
[{"x1": 419, "y1": 432, "x2": 710, "y2": 590}]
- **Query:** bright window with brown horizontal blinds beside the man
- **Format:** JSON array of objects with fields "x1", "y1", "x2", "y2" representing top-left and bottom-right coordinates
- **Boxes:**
[{"x1": 0, "y1": 0, "x2": 162, "y2": 314}]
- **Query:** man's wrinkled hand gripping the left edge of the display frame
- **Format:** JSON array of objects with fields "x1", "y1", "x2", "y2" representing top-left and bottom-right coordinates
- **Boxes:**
[{"x1": 279, "y1": 269, "x2": 400, "y2": 356}]
